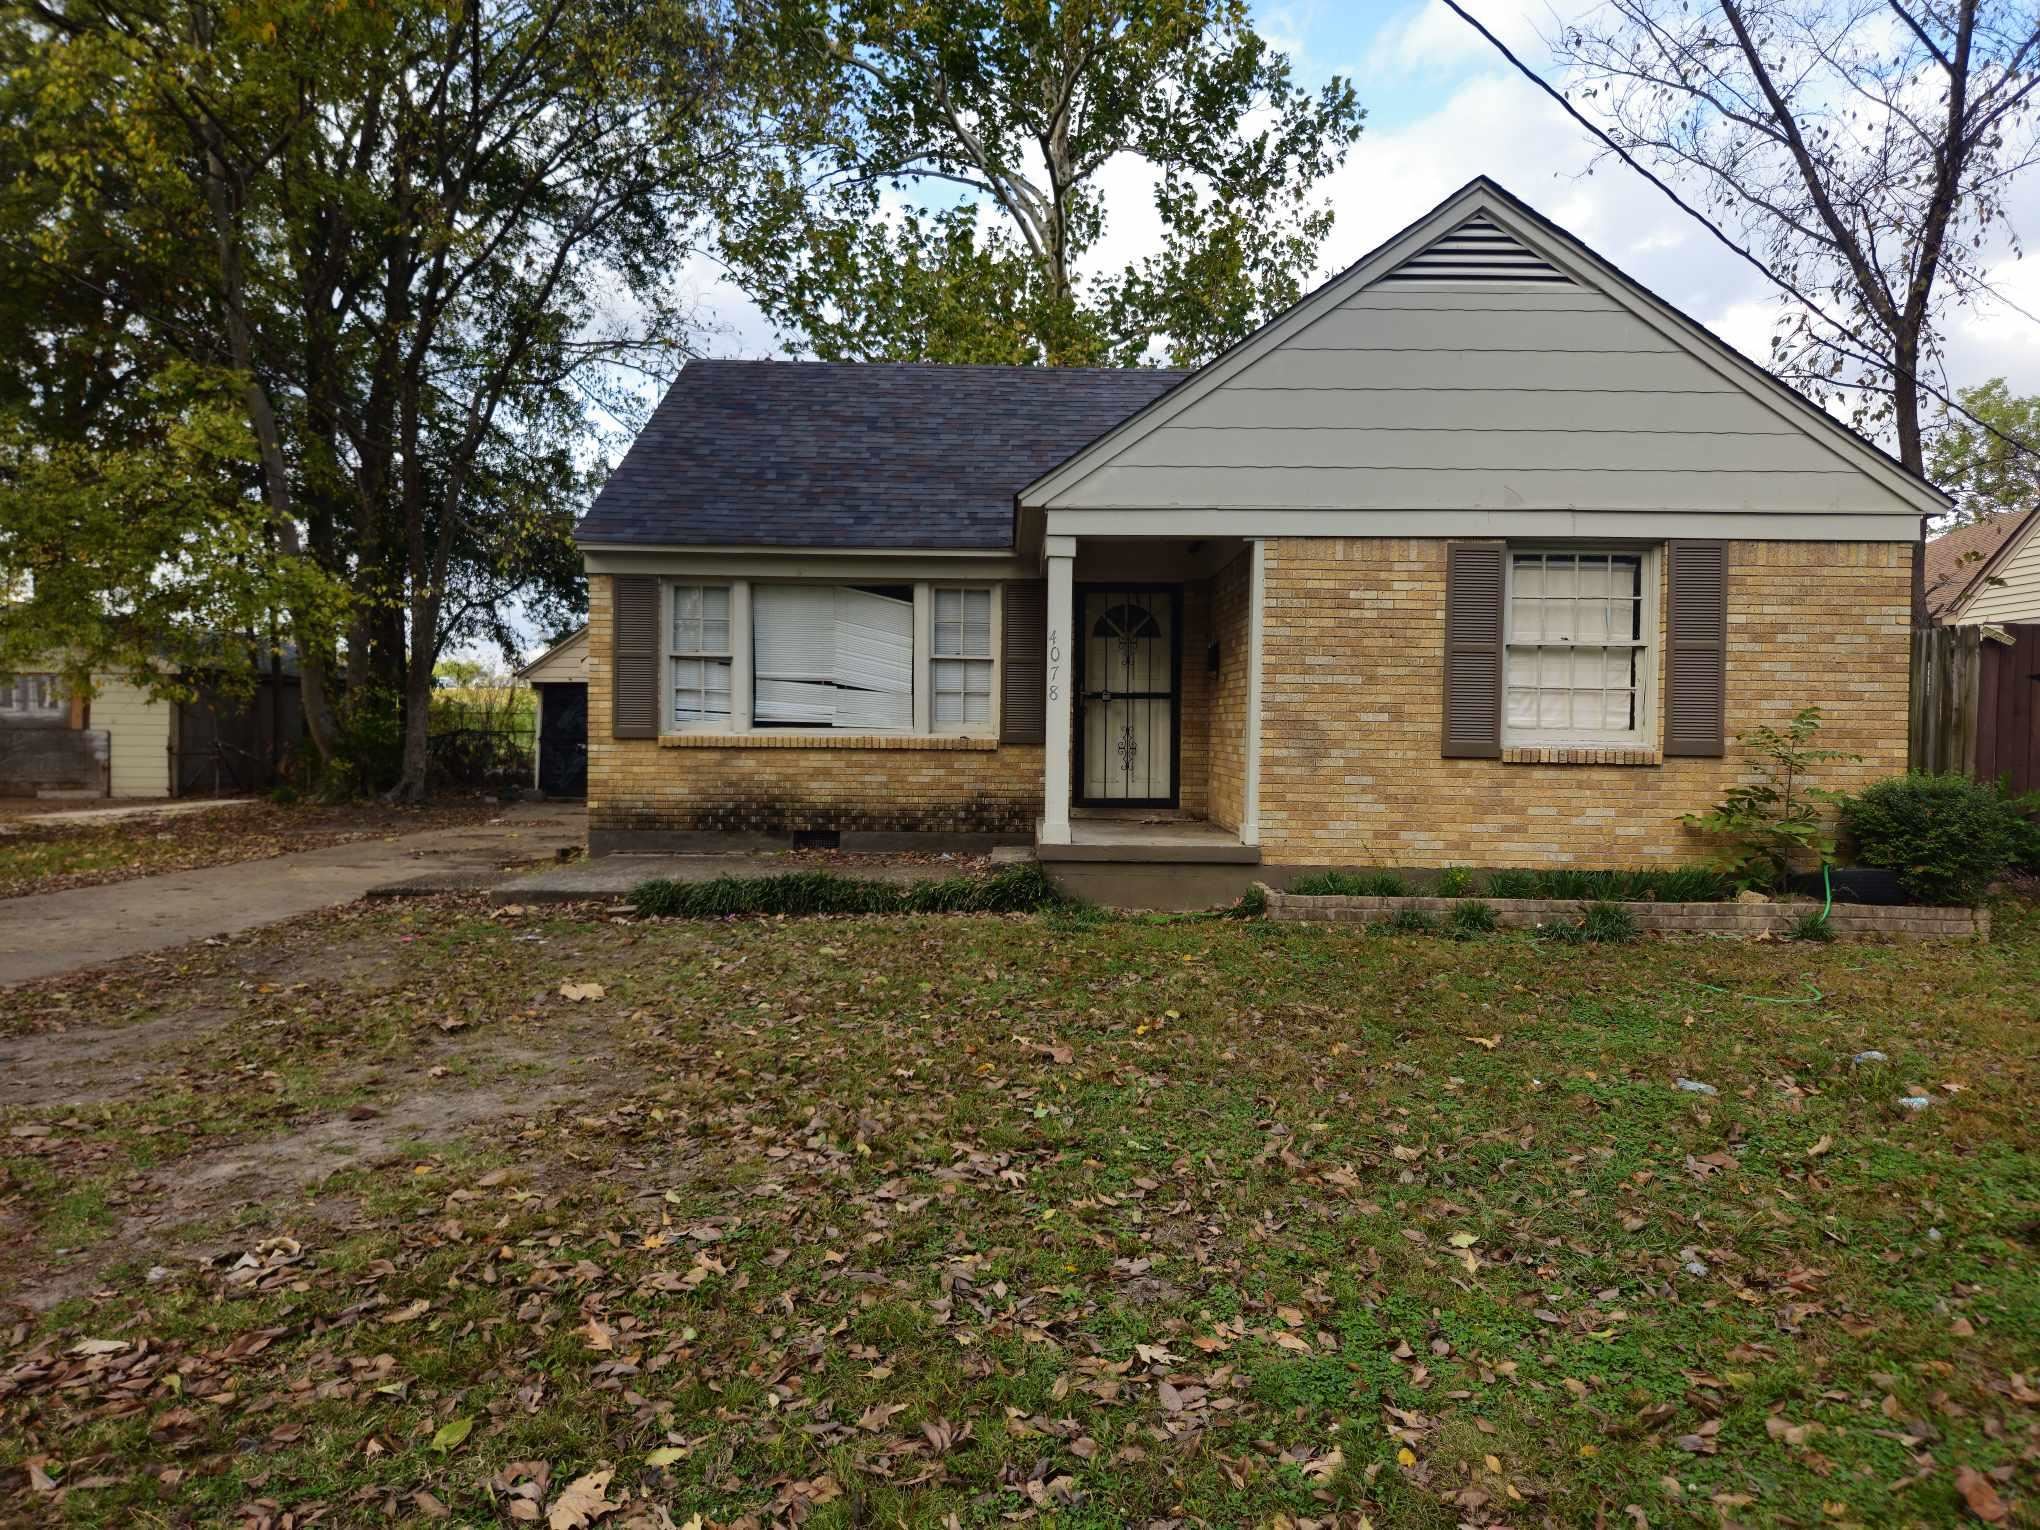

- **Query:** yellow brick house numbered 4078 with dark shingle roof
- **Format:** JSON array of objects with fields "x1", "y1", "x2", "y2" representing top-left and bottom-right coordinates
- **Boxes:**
[{"x1": 579, "y1": 180, "x2": 1946, "y2": 902}]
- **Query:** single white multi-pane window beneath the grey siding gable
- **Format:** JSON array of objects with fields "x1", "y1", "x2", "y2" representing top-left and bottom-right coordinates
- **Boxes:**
[{"x1": 1503, "y1": 551, "x2": 1650, "y2": 743}]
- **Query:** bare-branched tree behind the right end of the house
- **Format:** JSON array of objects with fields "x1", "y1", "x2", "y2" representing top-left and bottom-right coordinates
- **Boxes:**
[{"x1": 1557, "y1": 0, "x2": 2040, "y2": 616}]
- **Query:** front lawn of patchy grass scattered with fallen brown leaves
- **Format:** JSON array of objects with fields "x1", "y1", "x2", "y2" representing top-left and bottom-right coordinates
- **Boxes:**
[{"x1": 0, "y1": 902, "x2": 2040, "y2": 1526}]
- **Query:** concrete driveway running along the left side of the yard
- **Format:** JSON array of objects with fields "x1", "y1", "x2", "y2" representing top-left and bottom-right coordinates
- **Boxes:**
[{"x1": 0, "y1": 804, "x2": 588, "y2": 985}]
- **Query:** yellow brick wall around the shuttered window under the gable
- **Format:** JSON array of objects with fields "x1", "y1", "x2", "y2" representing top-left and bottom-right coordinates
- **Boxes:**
[{"x1": 1256, "y1": 539, "x2": 1911, "y2": 867}]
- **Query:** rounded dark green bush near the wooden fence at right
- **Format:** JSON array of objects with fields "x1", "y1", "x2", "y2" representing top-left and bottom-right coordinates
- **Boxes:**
[{"x1": 1842, "y1": 771, "x2": 2026, "y2": 904}]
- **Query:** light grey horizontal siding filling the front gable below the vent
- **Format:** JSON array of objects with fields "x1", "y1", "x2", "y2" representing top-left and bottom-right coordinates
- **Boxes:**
[{"x1": 1051, "y1": 286, "x2": 1909, "y2": 514}]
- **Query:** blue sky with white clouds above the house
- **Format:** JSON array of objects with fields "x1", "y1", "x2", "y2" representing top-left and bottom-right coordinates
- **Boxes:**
[{"x1": 673, "y1": 0, "x2": 2040, "y2": 392}]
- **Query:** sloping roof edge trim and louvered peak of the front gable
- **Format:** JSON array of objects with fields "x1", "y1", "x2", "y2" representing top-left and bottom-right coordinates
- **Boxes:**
[{"x1": 1020, "y1": 175, "x2": 1950, "y2": 514}]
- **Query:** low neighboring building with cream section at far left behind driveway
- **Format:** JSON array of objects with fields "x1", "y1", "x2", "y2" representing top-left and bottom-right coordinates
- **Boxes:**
[{"x1": 0, "y1": 663, "x2": 302, "y2": 798}]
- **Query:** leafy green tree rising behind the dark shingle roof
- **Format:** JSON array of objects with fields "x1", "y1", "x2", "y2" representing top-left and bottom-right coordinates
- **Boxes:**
[{"x1": 722, "y1": 0, "x2": 1363, "y2": 365}]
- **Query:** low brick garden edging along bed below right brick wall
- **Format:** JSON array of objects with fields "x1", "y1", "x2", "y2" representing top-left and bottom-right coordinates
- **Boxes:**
[{"x1": 1255, "y1": 883, "x2": 1991, "y2": 940}]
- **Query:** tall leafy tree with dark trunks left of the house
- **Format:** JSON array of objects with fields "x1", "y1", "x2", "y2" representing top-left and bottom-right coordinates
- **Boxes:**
[{"x1": 0, "y1": 0, "x2": 765, "y2": 798}]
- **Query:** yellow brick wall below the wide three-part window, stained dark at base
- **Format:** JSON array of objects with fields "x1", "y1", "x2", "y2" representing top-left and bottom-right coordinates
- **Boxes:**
[{"x1": 588, "y1": 573, "x2": 1042, "y2": 834}]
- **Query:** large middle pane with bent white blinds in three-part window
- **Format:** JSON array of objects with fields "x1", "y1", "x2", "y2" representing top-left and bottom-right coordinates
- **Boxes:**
[{"x1": 751, "y1": 583, "x2": 914, "y2": 732}]
